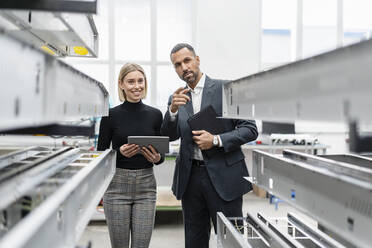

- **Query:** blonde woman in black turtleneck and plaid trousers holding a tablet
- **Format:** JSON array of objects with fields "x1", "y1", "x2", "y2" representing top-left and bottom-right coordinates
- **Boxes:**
[{"x1": 97, "y1": 63, "x2": 164, "y2": 248}]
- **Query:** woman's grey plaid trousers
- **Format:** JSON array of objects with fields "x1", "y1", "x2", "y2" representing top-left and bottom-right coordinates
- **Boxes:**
[{"x1": 103, "y1": 168, "x2": 156, "y2": 248}]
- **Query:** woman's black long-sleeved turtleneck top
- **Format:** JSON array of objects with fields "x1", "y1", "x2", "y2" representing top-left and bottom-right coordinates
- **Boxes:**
[{"x1": 97, "y1": 101, "x2": 164, "y2": 170}]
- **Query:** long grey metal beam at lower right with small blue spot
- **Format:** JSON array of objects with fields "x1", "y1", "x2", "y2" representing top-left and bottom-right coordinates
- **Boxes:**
[{"x1": 247, "y1": 150, "x2": 372, "y2": 247}]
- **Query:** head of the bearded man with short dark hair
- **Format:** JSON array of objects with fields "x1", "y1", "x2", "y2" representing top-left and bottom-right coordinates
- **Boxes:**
[{"x1": 171, "y1": 47, "x2": 200, "y2": 86}]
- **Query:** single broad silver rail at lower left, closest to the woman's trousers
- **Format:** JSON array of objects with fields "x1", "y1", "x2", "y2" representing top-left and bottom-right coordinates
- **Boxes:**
[{"x1": 0, "y1": 149, "x2": 116, "y2": 248}]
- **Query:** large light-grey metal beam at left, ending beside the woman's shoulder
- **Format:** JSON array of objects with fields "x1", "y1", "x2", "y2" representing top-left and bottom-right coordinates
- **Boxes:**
[{"x1": 0, "y1": 33, "x2": 109, "y2": 131}]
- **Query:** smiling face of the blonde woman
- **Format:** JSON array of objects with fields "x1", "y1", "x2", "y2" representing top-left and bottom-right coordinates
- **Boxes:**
[{"x1": 119, "y1": 71, "x2": 146, "y2": 102}]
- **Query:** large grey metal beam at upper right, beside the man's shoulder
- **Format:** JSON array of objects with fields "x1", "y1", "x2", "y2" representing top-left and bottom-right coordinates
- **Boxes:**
[{"x1": 223, "y1": 40, "x2": 372, "y2": 122}]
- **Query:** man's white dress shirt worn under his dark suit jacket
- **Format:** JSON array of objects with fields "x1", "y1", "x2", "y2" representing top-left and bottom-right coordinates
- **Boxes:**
[{"x1": 169, "y1": 73, "x2": 222, "y2": 160}]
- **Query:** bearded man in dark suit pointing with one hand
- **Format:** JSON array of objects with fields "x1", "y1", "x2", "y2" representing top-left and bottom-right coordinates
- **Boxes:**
[{"x1": 161, "y1": 43, "x2": 258, "y2": 248}]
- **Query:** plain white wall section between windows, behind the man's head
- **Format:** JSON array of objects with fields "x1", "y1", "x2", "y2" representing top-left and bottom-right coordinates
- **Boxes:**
[{"x1": 195, "y1": 0, "x2": 261, "y2": 79}]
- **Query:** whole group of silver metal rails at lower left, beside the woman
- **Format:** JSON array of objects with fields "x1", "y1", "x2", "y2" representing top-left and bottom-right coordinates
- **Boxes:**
[{"x1": 0, "y1": 147, "x2": 116, "y2": 248}]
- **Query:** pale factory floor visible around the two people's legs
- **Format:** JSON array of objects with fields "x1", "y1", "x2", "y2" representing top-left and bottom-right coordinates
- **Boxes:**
[{"x1": 79, "y1": 193, "x2": 312, "y2": 248}]
